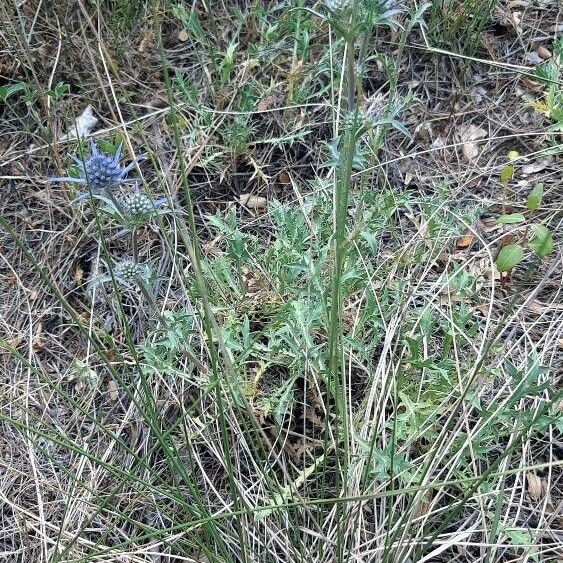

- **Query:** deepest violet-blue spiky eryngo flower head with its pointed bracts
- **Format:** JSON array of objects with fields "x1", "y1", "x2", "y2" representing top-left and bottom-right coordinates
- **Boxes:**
[{"x1": 49, "y1": 142, "x2": 142, "y2": 197}]
